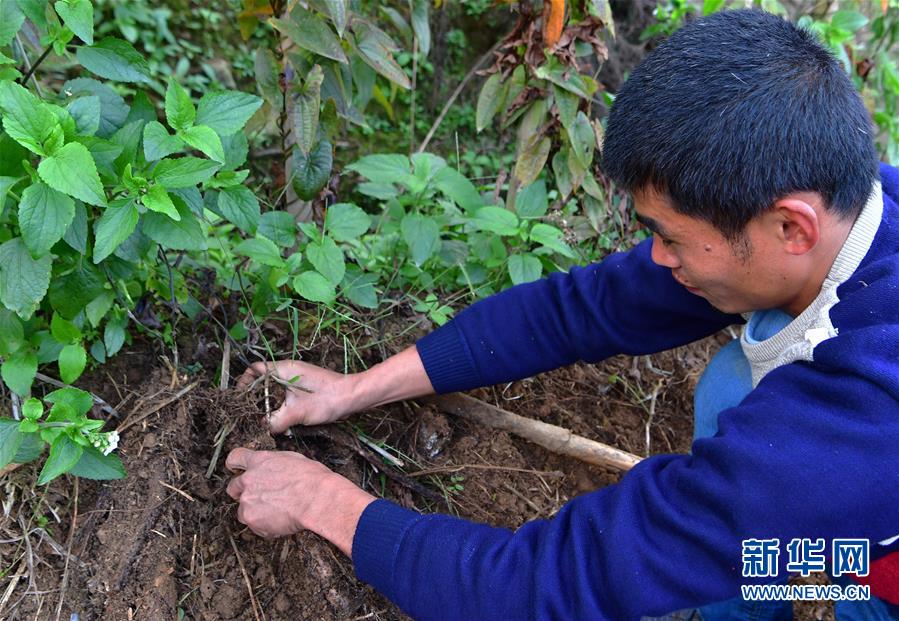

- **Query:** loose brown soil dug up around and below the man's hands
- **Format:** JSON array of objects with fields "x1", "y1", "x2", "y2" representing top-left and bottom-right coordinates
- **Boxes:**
[{"x1": 0, "y1": 320, "x2": 832, "y2": 621}]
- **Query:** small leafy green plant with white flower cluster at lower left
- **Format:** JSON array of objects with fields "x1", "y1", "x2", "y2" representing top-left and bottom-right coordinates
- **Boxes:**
[{"x1": 0, "y1": 388, "x2": 125, "y2": 485}]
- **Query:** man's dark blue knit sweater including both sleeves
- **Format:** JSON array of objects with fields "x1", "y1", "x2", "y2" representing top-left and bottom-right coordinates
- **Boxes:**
[{"x1": 353, "y1": 166, "x2": 899, "y2": 621}]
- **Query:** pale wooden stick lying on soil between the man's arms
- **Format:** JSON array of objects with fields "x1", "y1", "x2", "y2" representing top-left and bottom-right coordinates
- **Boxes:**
[{"x1": 429, "y1": 393, "x2": 640, "y2": 470}]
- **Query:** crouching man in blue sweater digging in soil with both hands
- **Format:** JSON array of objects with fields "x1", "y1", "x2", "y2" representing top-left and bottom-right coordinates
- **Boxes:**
[{"x1": 228, "y1": 11, "x2": 899, "y2": 620}]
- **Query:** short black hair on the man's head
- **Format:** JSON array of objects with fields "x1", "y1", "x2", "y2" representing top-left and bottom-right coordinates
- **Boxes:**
[{"x1": 602, "y1": 9, "x2": 879, "y2": 240}]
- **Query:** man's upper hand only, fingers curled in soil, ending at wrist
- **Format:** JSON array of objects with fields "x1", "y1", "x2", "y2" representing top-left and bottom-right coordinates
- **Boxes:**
[{"x1": 237, "y1": 360, "x2": 355, "y2": 433}]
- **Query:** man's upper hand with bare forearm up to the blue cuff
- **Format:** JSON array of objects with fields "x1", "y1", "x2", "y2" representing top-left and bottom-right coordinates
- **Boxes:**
[{"x1": 237, "y1": 345, "x2": 434, "y2": 433}]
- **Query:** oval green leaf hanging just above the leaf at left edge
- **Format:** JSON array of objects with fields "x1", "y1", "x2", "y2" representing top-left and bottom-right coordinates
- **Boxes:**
[{"x1": 19, "y1": 183, "x2": 75, "y2": 258}]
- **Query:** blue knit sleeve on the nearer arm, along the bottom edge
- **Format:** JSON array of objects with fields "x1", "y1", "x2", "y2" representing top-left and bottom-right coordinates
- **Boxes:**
[{"x1": 353, "y1": 363, "x2": 899, "y2": 621}]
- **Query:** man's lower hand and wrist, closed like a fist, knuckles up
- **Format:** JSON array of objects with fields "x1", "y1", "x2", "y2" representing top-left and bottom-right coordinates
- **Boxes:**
[{"x1": 225, "y1": 448, "x2": 375, "y2": 556}]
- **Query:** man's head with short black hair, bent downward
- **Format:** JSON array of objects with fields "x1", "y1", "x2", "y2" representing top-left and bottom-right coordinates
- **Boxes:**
[{"x1": 603, "y1": 10, "x2": 878, "y2": 312}]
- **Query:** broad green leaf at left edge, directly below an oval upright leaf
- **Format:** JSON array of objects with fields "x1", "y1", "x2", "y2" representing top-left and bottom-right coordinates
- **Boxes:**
[{"x1": 0, "y1": 237, "x2": 53, "y2": 320}]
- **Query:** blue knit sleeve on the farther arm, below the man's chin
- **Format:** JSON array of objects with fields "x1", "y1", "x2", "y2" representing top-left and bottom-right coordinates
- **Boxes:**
[{"x1": 416, "y1": 240, "x2": 742, "y2": 393}]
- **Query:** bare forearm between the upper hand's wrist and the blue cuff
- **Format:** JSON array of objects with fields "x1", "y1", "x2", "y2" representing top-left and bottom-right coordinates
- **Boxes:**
[{"x1": 352, "y1": 345, "x2": 434, "y2": 411}]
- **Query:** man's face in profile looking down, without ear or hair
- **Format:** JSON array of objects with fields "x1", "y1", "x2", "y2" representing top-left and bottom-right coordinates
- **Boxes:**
[{"x1": 634, "y1": 190, "x2": 789, "y2": 313}]
